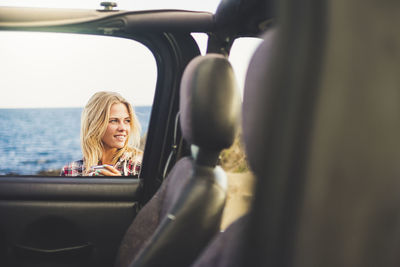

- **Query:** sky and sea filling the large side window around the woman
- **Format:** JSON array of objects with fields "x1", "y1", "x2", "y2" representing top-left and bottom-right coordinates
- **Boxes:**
[{"x1": 0, "y1": 32, "x2": 157, "y2": 175}]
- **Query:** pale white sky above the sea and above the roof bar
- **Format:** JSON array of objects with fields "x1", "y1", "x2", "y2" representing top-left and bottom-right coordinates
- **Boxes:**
[{"x1": 0, "y1": 0, "x2": 260, "y2": 108}]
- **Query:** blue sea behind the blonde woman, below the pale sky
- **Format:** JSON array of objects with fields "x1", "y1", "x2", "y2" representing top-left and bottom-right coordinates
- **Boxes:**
[{"x1": 0, "y1": 106, "x2": 151, "y2": 175}]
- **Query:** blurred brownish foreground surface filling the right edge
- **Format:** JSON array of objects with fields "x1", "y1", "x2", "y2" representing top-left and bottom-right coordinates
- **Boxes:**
[{"x1": 282, "y1": 0, "x2": 400, "y2": 267}]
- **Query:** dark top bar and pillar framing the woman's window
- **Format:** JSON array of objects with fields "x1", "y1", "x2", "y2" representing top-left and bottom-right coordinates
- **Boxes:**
[{"x1": 0, "y1": 7, "x2": 213, "y2": 205}]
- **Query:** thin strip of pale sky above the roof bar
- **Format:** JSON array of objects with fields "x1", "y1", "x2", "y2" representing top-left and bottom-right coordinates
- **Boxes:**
[{"x1": 0, "y1": 0, "x2": 220, "y2": 13}]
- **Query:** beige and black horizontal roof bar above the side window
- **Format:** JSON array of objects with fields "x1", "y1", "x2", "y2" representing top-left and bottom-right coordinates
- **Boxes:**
[{"x1": 0, "y1": 7, "x2": 214, "y2": 31}]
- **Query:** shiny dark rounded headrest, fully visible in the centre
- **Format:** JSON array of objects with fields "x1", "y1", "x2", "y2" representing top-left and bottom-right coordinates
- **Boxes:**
[{"x1": 180, "y1": 54, "x2": 241, "y2": 161}]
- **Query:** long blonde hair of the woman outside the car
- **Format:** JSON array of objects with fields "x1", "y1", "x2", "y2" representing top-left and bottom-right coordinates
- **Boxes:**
[{"x1": 81, "y1": 92, "x2": 141, "y2": 175}]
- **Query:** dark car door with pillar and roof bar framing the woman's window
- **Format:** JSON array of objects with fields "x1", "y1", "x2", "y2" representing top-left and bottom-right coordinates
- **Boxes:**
[{"x1": 0, "y1": 7, "x2": 213, "y2": 266}]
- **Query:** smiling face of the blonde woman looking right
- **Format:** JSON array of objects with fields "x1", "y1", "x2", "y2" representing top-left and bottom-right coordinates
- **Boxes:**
[{"x1": 101, "y1": 103, "x2": 131, "y2": 150}]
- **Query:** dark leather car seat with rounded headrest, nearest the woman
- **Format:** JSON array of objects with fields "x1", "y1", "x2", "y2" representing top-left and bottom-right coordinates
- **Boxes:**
[{"x1": 116, "y1": 54, "x2": 240, "y2": 267}]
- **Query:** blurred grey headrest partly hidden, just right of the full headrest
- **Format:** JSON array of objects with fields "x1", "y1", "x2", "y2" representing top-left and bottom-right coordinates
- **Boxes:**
[{"x1": 242, "y1": 29, "x2": 276, "y2": 173}]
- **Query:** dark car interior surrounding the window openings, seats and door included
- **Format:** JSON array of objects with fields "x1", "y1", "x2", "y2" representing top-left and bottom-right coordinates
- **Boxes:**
[{"x1": 0, "y1": 0, "x2": 400, "y2": 267}]
